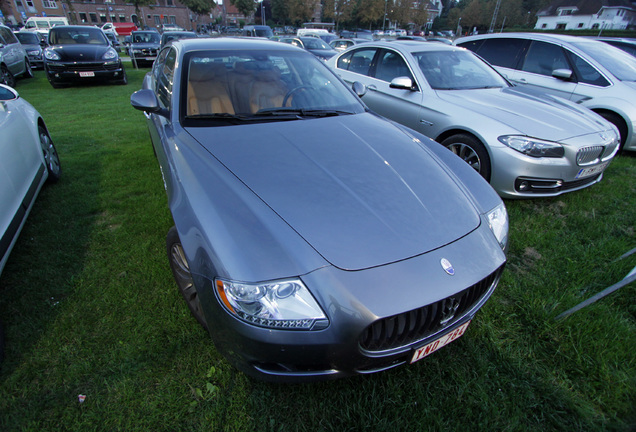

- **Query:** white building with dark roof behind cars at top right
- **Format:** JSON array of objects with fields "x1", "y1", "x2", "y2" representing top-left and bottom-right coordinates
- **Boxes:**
[{"x1": 535, "y1": 0, "x2": 636, "y2": 30}]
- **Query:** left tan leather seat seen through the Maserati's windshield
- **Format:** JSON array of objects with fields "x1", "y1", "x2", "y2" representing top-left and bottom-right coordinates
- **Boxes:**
[{"x1": 188, "y1": 62, "x2": 235, "y2": 115}]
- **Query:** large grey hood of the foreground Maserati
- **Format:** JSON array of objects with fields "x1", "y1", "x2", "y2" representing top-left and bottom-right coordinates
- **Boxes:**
[{"x1": 187, "y1": 113, "x2": 480, "y2": 270}]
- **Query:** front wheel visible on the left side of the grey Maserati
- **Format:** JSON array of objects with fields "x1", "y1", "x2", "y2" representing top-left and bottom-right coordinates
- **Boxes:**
[{"x1": 166, "y1": 226, "x2": 208, "y2": 330}]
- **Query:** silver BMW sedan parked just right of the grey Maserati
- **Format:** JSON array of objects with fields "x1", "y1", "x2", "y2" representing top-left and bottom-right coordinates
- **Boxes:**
[{"x1": 328, "y1": 41, "x2": 618, "y2": 198}]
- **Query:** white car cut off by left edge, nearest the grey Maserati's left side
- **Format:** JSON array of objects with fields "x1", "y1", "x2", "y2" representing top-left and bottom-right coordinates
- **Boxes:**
[{"x1": 0, "y1": 84, "x2": 62, "y2": 273}]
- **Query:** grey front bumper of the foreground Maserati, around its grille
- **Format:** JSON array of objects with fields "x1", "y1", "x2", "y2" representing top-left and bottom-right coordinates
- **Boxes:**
[{"x1": 194, "y1": 223, "x2": 505, "y2": 382}]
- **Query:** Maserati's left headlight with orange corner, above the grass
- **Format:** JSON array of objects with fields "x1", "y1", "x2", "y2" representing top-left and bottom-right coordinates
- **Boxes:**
[{"x1": 216, "y1": 279, "x2": 328, "y2": 330}]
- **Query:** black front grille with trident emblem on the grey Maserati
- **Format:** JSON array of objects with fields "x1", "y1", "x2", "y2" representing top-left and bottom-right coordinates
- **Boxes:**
[{"x1": 359, "y1": 266, "x2": 503, "y2": 351}]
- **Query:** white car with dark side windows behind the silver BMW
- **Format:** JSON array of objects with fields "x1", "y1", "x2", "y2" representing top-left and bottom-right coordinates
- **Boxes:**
[{"x1": 455, "y1": 33, "x2": 636, "y2": 151}]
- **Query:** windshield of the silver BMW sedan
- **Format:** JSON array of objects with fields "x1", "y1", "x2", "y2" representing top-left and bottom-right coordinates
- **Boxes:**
[{"x1": 413, "y1": 51, "x2": 509, "y2": 90}]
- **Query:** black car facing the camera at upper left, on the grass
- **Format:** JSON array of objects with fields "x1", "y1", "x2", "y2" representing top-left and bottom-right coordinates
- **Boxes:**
[{"x1": 44, "y1": 26, "x2": 128, "y2": 88}]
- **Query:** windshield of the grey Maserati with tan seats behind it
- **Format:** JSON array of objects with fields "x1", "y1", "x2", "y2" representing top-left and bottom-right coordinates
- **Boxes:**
[{"x1": 181, "y1": 50, "x2": 365, "y2": 125}]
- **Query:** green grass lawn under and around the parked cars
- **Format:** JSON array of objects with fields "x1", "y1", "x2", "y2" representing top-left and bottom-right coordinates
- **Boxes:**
[{"x1": 0, "y1": 66, "x2": 636, "y2": 431}]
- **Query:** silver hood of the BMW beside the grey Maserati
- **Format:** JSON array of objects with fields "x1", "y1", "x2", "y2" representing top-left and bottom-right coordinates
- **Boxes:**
[{"x1": 437, "y1": 87, "x2": 609, "y2": 141}]
